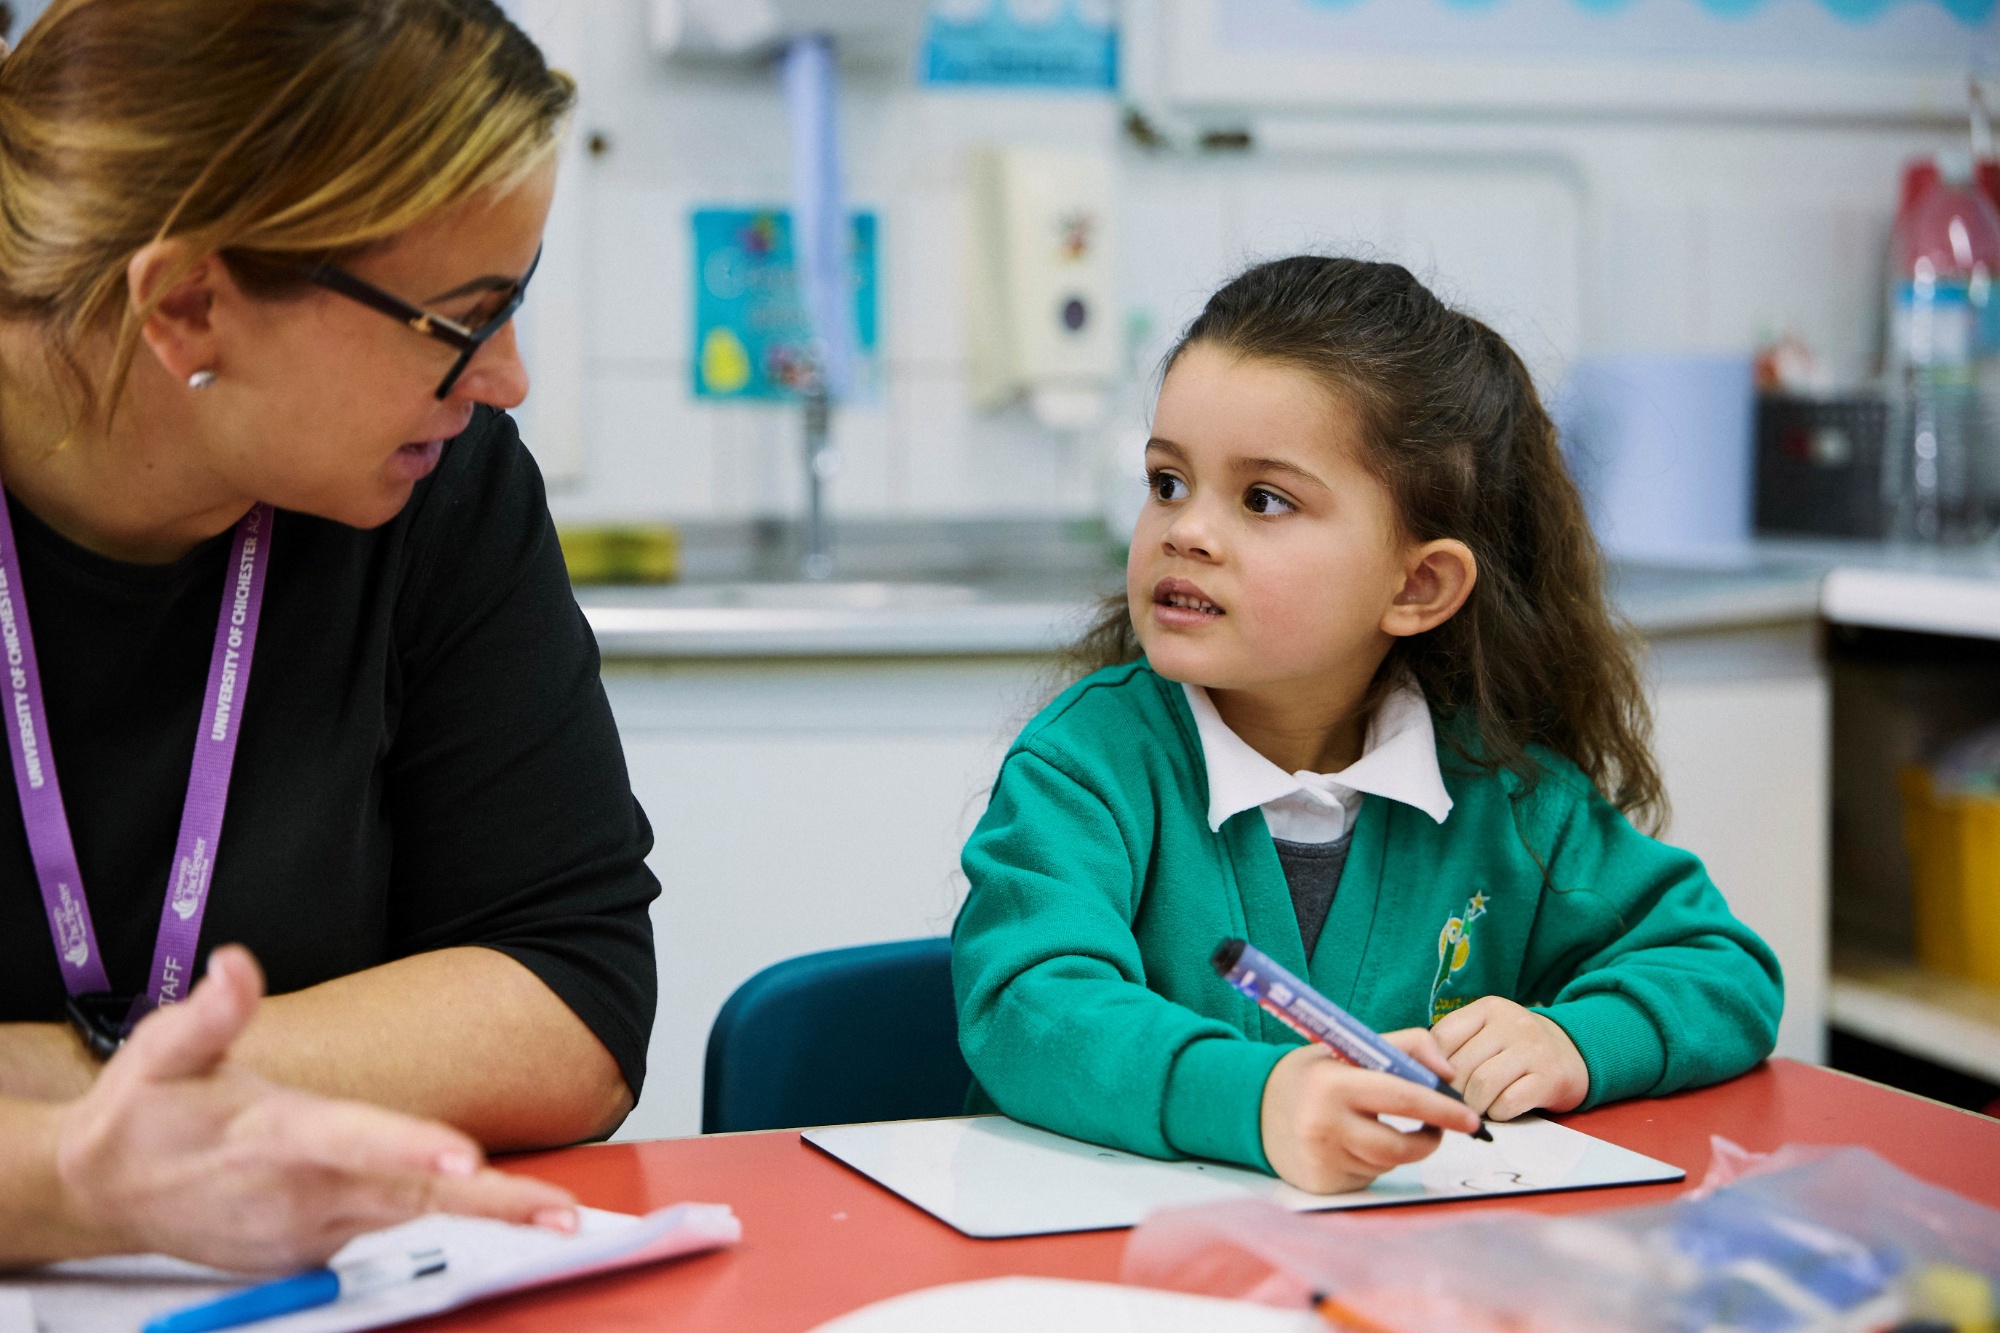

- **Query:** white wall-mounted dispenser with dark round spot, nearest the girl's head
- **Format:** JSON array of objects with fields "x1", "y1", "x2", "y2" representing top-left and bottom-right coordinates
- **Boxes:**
[{"x1": 966, "y1": 146, "x2": 1118, "y2": 430}]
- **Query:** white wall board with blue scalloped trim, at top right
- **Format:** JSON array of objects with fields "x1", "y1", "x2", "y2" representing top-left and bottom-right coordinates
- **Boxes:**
[{"x1": 1158, "y1": 0, "x2": 2000, "y2": 118}]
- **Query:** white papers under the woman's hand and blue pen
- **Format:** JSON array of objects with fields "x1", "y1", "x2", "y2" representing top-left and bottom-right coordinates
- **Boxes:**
[{"x1": 0, "y1": 1203, "x2": 742, "y2": 1333}]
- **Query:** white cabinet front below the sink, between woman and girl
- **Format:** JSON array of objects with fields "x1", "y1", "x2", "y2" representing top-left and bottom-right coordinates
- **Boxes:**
[{"x1": 604, "y1": 658, "x2": 1042, "y2": 1139}]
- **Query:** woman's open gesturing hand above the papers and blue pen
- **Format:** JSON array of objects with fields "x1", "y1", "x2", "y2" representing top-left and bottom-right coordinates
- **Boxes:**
[{"x1": 54, "y1": 947, "x2": 576, "y2": 1273}]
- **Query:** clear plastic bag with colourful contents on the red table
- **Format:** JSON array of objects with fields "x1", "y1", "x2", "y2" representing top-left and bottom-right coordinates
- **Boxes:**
[{"x1": 1124, "y1": 1139, "x2": 2000, "y2": 1333}]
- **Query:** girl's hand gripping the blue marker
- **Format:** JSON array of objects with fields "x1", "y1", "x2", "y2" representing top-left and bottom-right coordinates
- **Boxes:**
[{"x1": 1262, "y1": 1027, "x2": 1480, "y2": 1195}]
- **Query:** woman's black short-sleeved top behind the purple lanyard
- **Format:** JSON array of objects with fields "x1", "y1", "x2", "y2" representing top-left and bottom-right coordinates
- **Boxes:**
[{"x1": 0, "y1": 408, "x2": 660, "y2": 1097}]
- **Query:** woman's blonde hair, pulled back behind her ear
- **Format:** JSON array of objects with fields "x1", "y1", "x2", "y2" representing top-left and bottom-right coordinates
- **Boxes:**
[{"x1": 0, "y1": 0, "x2": 576, "y2": 418}]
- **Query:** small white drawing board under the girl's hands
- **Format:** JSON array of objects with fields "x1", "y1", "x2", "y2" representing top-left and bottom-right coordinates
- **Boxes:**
[{"x1": 804, "y1": 1115, "x2": 1686, "y2": 1237}]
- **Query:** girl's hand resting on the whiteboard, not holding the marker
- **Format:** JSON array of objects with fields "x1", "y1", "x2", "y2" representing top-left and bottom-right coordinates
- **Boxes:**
[{"x1": 1430, "y1": 995, "x2": 1590, "y2": 1121}]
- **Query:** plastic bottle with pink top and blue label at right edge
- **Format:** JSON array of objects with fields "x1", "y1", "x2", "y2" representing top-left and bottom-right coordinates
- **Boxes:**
[{"x1": 1882, "y1": 154, "x2": 2000, "y2": 542}]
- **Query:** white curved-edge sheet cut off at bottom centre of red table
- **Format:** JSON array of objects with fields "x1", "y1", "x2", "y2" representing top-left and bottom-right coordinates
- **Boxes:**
[{"x1": 812, "y1": 1277, "x2": 1326, "y2": 1333}]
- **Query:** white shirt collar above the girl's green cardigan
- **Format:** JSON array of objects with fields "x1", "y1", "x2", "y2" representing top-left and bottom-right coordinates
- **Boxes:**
[{"x1": 1180, "y1": 683, "x2": 1452, "y2": 837}]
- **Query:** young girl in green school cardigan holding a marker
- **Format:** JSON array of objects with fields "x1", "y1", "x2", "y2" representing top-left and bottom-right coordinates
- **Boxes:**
[{"x1": 952, "y1": 256, "x2": 1782, "y2": 1193}]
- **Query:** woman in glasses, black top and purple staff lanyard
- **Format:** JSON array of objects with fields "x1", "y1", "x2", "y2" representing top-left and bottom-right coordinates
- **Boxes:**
[{"x1": 0, "y1": 0, "x2": 658, "y2": 1263}]
